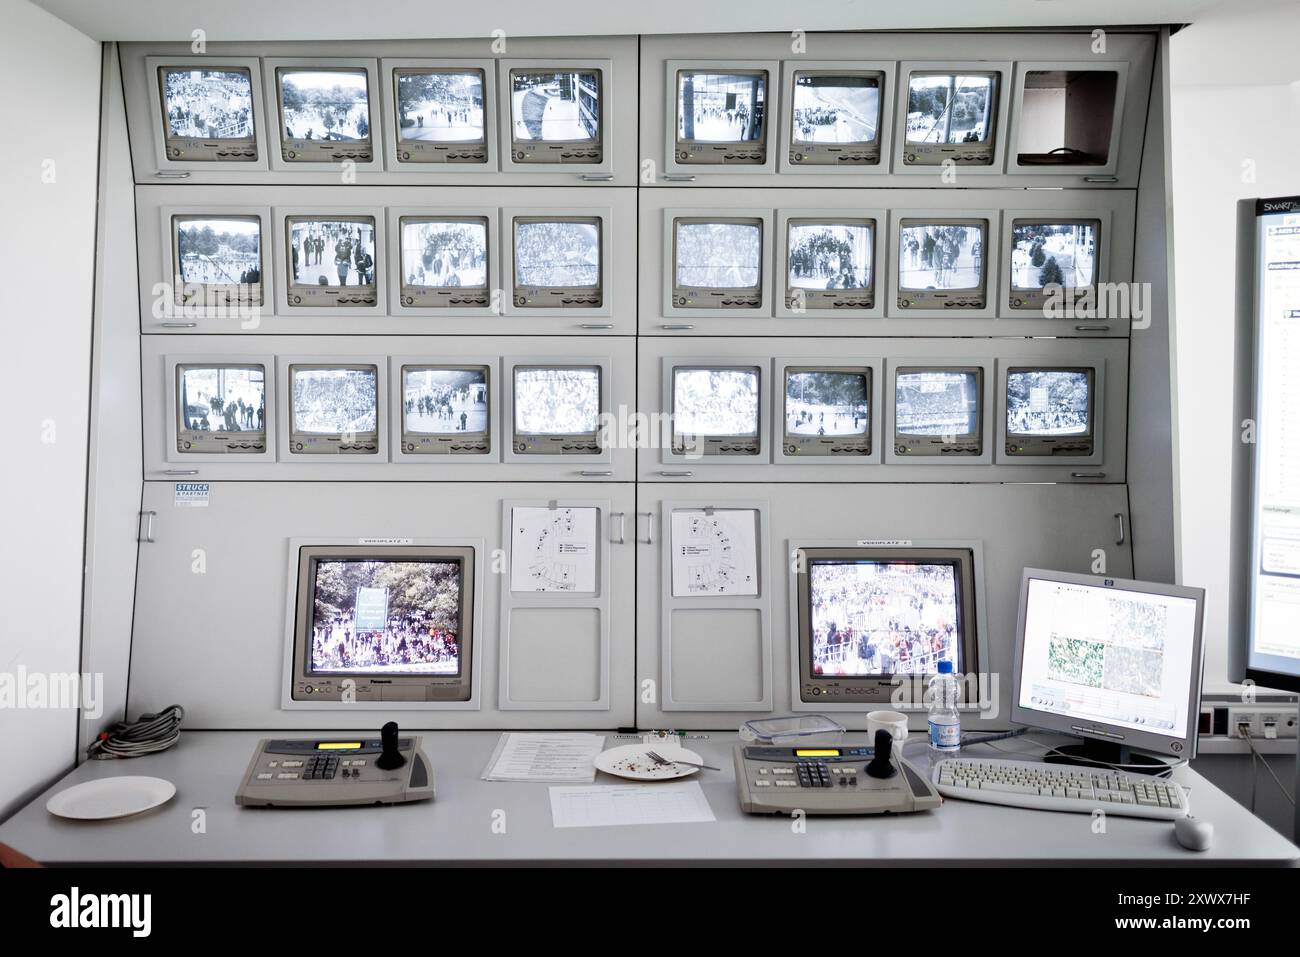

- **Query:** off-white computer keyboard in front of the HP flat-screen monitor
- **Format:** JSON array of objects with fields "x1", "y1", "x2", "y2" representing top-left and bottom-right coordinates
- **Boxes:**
[{"x1": 931, "y1": 758, "x2": 1188, "y2": 820}]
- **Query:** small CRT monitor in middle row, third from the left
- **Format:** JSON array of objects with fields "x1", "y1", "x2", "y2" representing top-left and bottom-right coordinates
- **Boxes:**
[{"x1": 398, "y1": 216, "x2": 491, "y2": 308}]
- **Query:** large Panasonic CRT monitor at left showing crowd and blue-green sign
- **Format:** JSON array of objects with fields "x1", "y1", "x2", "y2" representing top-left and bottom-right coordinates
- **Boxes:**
[{"x1": 290, "y1": 545, "x2": 475, "y2": 706}]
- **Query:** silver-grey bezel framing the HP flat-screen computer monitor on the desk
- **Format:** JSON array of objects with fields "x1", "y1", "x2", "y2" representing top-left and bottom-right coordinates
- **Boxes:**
[{"x1": 1010, "y1": 568, "x2": 1205, "y2": 759}]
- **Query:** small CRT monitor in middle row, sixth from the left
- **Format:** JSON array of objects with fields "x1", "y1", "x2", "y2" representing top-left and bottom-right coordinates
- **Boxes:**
[{"x1": 785, "y1": 217, "x2": 876, "y2": 309}]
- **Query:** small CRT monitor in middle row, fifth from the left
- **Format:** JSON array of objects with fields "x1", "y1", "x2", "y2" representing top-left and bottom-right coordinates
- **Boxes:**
[{"x1": 672, "y1": 216, "x2": 763, "y2": 309}]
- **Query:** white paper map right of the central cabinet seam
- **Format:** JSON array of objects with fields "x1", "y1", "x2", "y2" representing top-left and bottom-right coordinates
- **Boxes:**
[{"x1": 672, "y1": 508, "x2": 758, "y2": 598}]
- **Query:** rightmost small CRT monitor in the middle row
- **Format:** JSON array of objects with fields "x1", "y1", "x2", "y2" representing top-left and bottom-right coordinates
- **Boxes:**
[{"x1": 1008, "y1": 220, "x2": 1101, "y2": 309}]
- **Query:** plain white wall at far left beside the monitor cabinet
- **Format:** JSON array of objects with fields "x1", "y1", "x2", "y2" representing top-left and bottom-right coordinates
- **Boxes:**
[{"x1": 0, "y1": 0, "x2": 100, "y2": 818}]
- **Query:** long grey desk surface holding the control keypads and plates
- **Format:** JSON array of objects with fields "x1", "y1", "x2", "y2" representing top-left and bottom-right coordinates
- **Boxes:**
[{"x1": 0, "y1": 731, "x2": 1300, "y2": 866}]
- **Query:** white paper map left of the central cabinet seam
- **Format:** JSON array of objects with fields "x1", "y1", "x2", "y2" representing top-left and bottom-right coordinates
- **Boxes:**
[{"x1": 510, "y1": 506, "x2": 597, "y2": 594}]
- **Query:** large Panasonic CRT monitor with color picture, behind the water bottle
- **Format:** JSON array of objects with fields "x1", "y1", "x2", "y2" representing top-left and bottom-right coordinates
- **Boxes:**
[{"x1": 793, "y1": 546, "x2": 979, "y2": 703}]
